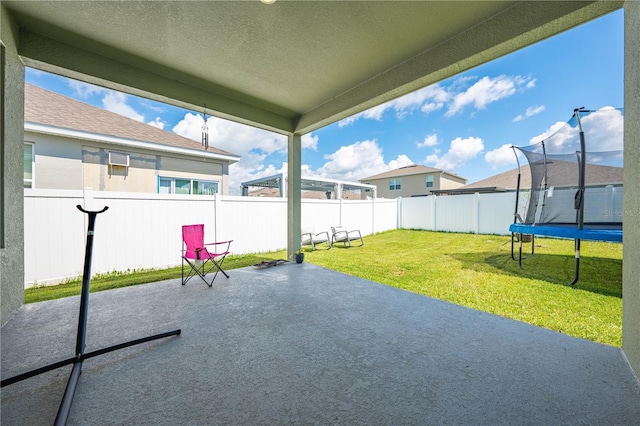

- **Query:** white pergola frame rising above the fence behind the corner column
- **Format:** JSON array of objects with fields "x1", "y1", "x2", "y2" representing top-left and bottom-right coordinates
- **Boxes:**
[{"x1": 240, "y1": 173, "x2": 377, "y2": 200}]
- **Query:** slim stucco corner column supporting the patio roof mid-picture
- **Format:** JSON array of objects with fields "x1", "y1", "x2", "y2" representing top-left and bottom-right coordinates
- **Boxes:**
[{"x1": 287, "y1": 133, "x2": 302, "y2": 260}]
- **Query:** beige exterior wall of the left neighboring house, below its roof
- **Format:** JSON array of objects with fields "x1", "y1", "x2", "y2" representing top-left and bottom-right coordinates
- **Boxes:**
[{"x1": 24, "y1": 132, "x2": 228, "y2": 194}]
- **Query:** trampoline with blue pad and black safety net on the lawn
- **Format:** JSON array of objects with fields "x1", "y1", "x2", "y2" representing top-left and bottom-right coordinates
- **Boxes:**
[{"x1": 509, "y1": 108, "x2": 623, "y2": 285}]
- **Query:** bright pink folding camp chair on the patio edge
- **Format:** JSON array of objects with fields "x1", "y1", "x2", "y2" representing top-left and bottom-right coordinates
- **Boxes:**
[{"x1": 181, "y1": 225, "x2": 233, "y2": 287}]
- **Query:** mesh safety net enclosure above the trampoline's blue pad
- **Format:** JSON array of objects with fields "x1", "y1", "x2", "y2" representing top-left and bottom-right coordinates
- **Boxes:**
[{"x1": 514, "y1": 108, "x2": 623, "y2": 229}]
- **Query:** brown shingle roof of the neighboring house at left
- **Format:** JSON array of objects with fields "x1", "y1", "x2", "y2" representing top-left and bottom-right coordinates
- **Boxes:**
[{"x1": 24, "y1": 84, "x2": 240, "y2": 163}]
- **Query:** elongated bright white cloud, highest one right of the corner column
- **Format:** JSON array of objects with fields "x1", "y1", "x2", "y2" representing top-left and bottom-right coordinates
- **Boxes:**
[{"x1": 445, "y1": 75, "x2": 535, "y2": 117}]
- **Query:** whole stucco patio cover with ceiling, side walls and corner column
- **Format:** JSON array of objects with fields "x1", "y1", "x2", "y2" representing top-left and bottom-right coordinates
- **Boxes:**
[{"x1": 0, "y1": 0, "x2": 640, "y2": 372}]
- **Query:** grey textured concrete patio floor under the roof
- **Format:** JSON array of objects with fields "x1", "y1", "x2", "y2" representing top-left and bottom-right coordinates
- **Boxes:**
[{"x1": 1, "y1": 263, "x2": 640, "y2": 426}]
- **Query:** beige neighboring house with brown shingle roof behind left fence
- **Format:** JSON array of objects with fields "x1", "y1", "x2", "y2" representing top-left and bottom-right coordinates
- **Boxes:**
[{"x1": 24, "y1": 84, "x2": 240, "y2": 195}]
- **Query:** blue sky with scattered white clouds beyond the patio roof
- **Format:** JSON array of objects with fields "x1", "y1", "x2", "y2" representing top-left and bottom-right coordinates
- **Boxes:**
[{"x1": 26, "y1": 10, "x2": 624, "y2": 195}]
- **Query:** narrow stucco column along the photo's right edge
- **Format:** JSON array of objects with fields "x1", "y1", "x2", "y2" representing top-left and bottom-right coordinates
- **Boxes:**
[{"x1": 622, "y1": 0, "x2": 640, "y2": 377}]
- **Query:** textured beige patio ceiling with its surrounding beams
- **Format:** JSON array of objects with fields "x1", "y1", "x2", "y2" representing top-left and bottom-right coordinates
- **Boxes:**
[{"x1": 3, "y1": 0, "x2": 623, "y2": 134}]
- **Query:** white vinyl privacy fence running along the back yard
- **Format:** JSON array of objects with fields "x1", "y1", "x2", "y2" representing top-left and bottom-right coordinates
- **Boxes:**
[{"x1": 24, "y1": 189, "x2": 524, "y2": 286}]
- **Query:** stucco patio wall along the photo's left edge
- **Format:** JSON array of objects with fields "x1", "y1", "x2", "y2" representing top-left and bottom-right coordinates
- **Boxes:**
[{"x1": 0, "y1": 4, "x2": 24, "y2": 324}]
